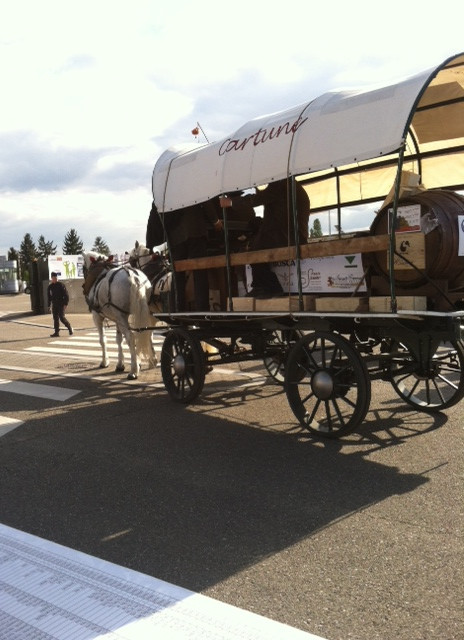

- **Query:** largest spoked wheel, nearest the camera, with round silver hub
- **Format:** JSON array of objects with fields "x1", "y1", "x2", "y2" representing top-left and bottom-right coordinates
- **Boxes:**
[{"x1": 285, "y1": 332, "x2": 371, "y2": 438}]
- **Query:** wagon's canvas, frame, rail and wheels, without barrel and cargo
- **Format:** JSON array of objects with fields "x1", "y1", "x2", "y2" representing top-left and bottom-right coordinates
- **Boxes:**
[{"x1": 149, "y1": 54, "x2": 464, "y2": 438}]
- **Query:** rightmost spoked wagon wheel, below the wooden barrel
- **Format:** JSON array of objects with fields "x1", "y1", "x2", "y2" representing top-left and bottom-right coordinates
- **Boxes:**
[{"x1": 390, "y1": 340, "x2": 464, "y2": 413}]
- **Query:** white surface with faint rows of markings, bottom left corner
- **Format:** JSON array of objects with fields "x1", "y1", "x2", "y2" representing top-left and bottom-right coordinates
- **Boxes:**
[{"x1": 0, "y1": 524, "x2": 321, "y2": 640}]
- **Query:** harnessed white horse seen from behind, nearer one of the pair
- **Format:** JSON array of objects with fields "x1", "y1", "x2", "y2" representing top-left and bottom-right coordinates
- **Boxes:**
[{"x1": 82, "y1": 252, "x2": 157, "y2": 380}]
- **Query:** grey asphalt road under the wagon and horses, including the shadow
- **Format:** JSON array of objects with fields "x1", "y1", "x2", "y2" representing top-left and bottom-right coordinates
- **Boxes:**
[{"x1": 0, "y1": 294, "x2": 464, "y2": 640}]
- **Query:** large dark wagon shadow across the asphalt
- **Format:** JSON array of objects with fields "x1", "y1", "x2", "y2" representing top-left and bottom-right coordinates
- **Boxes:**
[{"x1": 0, "y1": 381, "x2": 432, "y2": 591}]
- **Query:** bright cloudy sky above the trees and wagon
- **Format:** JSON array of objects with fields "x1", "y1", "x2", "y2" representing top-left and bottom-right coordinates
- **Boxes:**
[{"x1": 0, "y1": 0, "x2": 464, "y2": 255}]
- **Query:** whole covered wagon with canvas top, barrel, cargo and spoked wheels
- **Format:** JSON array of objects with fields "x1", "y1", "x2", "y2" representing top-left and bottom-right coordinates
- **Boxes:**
[{"x1": 148, "y1": 54, "x2": 464, "y2": 437}]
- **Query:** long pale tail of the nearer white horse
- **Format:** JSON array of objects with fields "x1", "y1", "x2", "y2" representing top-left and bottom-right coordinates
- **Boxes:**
[{"x1": 129, "y1": 269, "x2": 156, "y2": 361}]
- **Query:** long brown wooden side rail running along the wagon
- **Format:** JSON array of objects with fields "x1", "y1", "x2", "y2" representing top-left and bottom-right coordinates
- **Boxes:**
[{"x1": 174, "y1": 234, "x2": 390, "y2": 271}]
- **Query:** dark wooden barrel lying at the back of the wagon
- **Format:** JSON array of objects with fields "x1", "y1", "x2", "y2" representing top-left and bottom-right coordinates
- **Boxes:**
[{"x1": 370, "y1": 190, "x2": 464, "y2": 290}]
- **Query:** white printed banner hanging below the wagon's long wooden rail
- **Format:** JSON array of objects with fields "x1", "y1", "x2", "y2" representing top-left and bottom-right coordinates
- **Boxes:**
[{"x1": 246, "y1": 253, "x2": 367, "y2": 293}]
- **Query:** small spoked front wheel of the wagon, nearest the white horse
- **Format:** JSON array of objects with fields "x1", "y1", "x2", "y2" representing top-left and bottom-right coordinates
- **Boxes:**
[{"x1": 161, "y1": 329, "x2": 206, "y2": 404}]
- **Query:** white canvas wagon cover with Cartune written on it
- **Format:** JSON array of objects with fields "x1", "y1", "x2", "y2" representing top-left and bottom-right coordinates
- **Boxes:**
[{"x1": 153, "y1": 53, "x2": 464, "y2": 212}]
